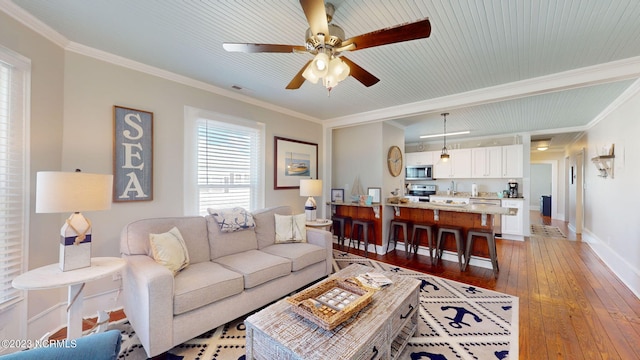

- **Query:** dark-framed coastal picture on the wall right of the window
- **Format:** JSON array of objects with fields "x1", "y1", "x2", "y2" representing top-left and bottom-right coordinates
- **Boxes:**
[{"x1": 273, "y1": 136, "x2": 318, "y2": 190}]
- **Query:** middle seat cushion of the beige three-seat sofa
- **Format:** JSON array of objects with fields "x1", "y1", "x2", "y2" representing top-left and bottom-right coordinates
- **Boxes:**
[{"x1": 215, "y1": 250, "x2": 291, "y2": 289}]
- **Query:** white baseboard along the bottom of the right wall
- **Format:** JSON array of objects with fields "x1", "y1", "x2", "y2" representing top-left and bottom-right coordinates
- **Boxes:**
[{"x1": 582, "y1": 229, "x2": 640, "y2": 299}]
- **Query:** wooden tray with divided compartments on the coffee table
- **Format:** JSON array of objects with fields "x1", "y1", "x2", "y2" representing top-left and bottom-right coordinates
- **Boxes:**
[{"x1": 287, "y1": 279, "x2": 375, "y2": 330}]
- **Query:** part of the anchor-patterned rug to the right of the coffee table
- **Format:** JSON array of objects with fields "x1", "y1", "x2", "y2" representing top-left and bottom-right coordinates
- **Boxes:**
[{"x1": 333, "y1": 250, "x2": 518, "y2": 360}]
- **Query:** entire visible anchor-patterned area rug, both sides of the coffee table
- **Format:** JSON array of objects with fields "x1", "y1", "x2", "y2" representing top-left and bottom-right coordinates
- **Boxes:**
[{"x1": 111, "y1": 250, "x2": 518, "y2": 360}]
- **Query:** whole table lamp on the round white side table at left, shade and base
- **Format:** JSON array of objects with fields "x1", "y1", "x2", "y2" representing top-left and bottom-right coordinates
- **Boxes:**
[{"x1": 36, "y1": 170, "x2": 113, "y2": 271}]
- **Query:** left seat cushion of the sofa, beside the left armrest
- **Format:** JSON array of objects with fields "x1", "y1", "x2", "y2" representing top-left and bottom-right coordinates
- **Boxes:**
[{"x1": 173, "y1": 261, "x2": 244, "y2": 315}]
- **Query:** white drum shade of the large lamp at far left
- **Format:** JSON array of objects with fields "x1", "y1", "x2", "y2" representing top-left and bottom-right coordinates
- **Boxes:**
[{"x1": 36, "y1": 171, "x2": 113, "y2": 213}]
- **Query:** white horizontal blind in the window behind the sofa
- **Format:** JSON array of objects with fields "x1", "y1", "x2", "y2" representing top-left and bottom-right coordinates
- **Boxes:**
[{"x1": 197, "y1": 118, "x2": 264, "y2": 215}]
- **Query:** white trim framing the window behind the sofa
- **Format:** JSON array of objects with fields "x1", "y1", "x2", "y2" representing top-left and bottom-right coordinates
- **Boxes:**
[{"x1": 183, "y1": 106, "x2": 266, "y2": 216}]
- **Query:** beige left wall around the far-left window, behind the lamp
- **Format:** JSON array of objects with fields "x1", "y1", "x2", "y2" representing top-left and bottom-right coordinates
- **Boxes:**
[{"x1": 0, "y1": 12, "x2": 66, "y2": 315}]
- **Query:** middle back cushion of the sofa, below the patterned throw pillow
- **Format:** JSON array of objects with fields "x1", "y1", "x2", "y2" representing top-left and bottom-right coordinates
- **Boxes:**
[{"x1": 206, "y1": 215, "x2": 258, "y2": 260}]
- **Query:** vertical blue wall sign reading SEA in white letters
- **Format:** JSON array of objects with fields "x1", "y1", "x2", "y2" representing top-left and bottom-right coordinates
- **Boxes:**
[{"x1": 113, "y1": 106, "x2": 153, "y2": 202}]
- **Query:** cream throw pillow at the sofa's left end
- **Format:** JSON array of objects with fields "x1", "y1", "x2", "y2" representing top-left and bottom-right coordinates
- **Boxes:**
[{"x1": 149, "y1": 226, "x2": 189, "y2": 276}]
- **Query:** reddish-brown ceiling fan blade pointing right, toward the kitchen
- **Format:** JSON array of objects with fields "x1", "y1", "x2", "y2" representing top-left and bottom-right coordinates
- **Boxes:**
[{"x1": 342, "y1": 19, "x2": 431, "y2": 51}]
